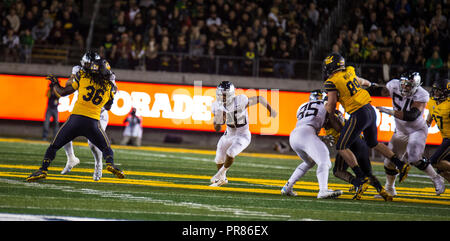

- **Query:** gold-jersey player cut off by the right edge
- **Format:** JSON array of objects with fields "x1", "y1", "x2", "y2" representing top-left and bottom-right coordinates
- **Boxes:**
[{"x1": 427, "y1": 79, "x2": 450, "y2": 182}]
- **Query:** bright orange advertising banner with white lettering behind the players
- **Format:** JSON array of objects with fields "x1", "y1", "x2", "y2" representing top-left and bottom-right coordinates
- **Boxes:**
[{"x1": 0, "y1": 75, "x2": 442, "y2": 145}]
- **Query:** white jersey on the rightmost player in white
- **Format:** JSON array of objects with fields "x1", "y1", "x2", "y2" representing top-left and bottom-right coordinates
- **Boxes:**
[{"x1": 386, "y1": 79, "x2": 430, "y2": 134}]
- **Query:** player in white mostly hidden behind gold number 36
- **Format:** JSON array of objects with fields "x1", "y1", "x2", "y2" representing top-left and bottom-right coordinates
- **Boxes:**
[{"x1": 61, "y1": 52, "x2": 117, "y2": 181}]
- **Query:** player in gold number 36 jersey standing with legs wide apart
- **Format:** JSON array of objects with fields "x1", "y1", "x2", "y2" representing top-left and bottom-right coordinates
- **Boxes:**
[{"x1": 26, "y1": 51, "x2": 125, "y2": 181}]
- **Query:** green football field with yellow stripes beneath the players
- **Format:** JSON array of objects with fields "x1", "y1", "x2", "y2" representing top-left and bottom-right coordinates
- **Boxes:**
[{"x1": 0, "y1": 138, "x2": 450, "y2": 221}]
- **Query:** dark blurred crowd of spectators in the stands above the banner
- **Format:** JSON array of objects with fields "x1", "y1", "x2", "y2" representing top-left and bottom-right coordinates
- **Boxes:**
[{"x1": 0, "y1": 0, "x2": 450, "y2": 86}]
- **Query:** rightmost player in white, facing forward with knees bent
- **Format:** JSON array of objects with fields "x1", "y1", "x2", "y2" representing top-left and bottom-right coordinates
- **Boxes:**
[{"x1": 377, "y1": 72, "x2": 445, "y2": 196}]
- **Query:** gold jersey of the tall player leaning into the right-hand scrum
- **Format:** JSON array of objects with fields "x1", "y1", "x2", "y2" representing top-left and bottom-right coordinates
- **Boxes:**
[{"x1": 324, "y1": 66, "x2": 371, "y2": 114}]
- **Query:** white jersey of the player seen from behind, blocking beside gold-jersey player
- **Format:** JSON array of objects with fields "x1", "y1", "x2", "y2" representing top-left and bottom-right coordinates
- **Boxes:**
[{"x1": 296, "y1": 100, "x2": 327, "y2": 133}]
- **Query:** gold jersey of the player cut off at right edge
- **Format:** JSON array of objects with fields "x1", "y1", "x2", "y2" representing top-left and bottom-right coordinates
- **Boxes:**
[{"x1": 428, "y1": 99, "x2": 450, "y2": 138}]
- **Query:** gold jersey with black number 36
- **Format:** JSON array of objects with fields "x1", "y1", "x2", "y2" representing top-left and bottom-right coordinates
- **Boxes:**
[{"x1": 72, "y1": 70, "x2": 114, "y2": 120}]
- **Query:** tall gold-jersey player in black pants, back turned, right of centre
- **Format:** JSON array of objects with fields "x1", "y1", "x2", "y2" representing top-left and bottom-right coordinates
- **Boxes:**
[{"x1": 322, "y1": 53, "x2": 411, "y2": 198}]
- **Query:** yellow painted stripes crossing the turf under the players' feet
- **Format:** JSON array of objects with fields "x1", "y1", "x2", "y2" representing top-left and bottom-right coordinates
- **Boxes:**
[{"x1": 0, "y1": 164, "x2": 450, "y2": 205}]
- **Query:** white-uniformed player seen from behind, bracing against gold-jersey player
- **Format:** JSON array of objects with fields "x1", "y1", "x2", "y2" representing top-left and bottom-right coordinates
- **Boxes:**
[{"x1": 281, "y1": 90, "x2": 342, "y2": 199}]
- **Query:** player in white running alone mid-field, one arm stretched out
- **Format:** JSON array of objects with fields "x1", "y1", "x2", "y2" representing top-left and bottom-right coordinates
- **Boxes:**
[{"x1": 210, "y1": 81, "x2": 277, "y2": 187}]
